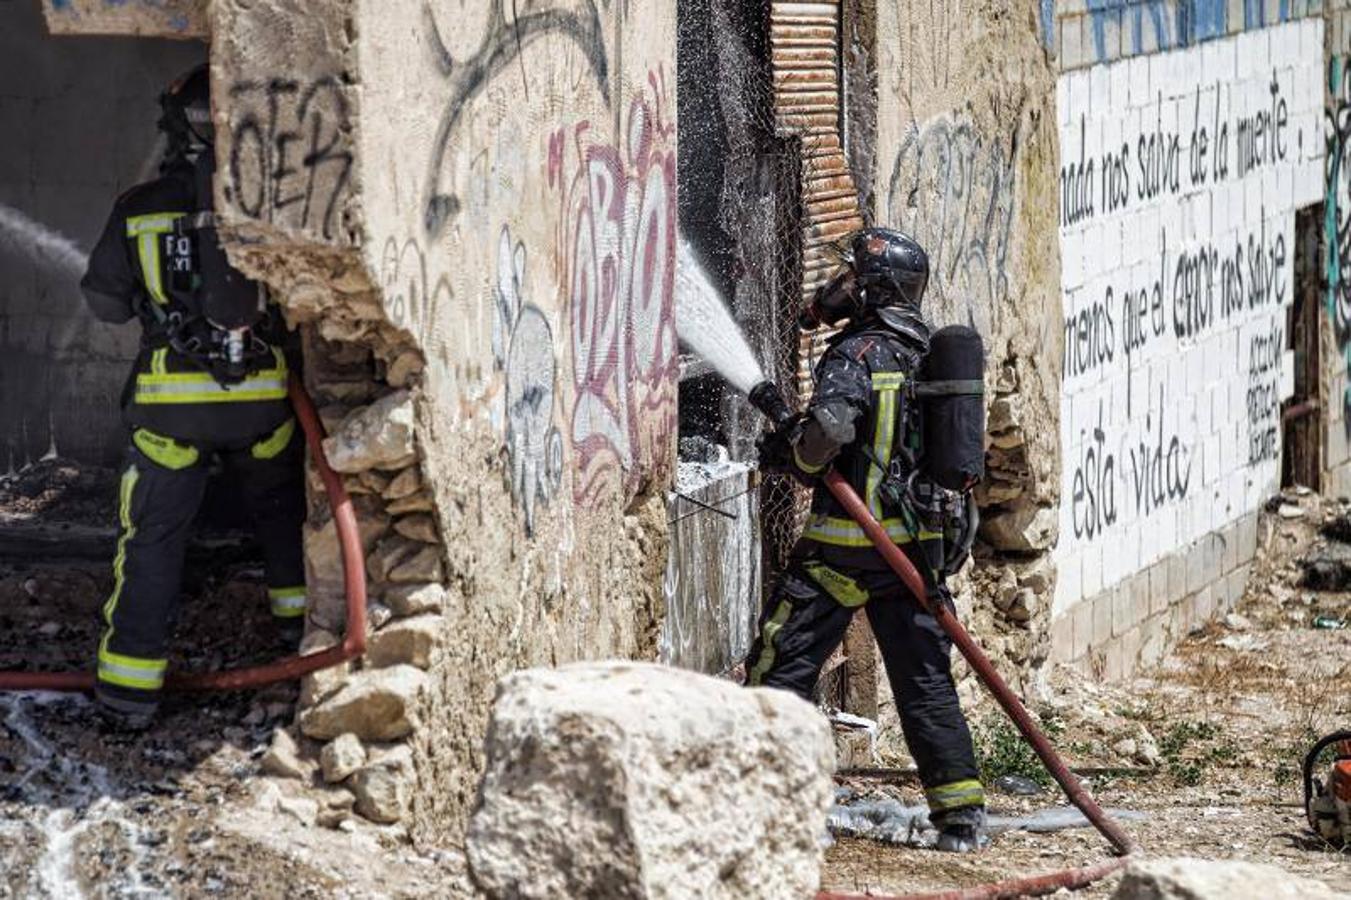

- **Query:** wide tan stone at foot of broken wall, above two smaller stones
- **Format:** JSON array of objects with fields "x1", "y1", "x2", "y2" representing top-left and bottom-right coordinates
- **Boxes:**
[{"x1": 300, "y1": 666, "x2": 427, "y2": 741}]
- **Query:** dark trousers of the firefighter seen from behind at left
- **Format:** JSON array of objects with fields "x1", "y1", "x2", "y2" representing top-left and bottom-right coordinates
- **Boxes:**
[{"x1": 97, "y1": 419, "x2": 305, "y2": 714}]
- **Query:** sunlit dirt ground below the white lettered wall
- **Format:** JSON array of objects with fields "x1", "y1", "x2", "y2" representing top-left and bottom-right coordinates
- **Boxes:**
[{"x1": 823, "y1": 486, "x2": 1351, "y2": 897}]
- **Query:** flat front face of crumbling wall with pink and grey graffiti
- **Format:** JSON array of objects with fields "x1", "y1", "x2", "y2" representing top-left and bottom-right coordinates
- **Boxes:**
[{"x1": 355, "y1": 0, "x2": 677, "y2": 843}]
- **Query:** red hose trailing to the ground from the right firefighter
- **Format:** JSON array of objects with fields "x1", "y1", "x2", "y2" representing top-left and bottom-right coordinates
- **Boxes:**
[{"x1": 816, "y1": 472, "x2": 1140, "y2": 900}]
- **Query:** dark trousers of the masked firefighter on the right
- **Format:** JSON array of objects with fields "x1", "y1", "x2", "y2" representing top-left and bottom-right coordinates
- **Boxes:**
[{"x1": 746, "y1": 542, "x2": 985, "y2": 827}]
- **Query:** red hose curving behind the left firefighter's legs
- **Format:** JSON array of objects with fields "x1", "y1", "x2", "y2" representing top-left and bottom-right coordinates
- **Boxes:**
[{"x1": 0, "y1": 374, "x2": 366, "y2": 691}]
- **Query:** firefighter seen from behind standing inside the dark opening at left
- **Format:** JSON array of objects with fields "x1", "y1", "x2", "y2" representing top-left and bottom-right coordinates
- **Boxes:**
[{"x1": 81, "y1": 66, "x2": 305, "y2": 727}]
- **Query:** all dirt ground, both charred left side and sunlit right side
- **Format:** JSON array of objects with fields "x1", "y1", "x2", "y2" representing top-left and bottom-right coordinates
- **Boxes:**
[{"x1": 0, "y1": 464, "x2": 1351, "y2": 900}]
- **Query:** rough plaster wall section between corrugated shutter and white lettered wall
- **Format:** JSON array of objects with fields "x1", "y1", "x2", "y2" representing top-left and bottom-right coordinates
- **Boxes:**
[{"x1": 873, "y1": 0, "x2": 1061, "y2": 668}]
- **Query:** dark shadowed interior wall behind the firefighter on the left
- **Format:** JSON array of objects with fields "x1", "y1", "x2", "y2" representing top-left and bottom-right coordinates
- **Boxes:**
[{"x1": 0, "y1": 3, "x2": 207, "y2": 472}]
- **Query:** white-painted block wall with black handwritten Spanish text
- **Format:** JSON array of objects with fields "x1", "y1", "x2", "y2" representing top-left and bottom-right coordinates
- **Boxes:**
[{"x1": 1046, "y1": 0, "x2": 1324, "y2": 677}]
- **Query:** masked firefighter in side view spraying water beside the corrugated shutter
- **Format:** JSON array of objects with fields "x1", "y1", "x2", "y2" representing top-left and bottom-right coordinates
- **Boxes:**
[{"x1": 746, "y1": 228, "x2": 985, "y2": 851}]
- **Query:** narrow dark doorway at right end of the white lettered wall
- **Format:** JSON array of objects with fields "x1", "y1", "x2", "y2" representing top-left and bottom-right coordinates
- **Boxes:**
[{"x1": 1281, "y1": 205, "x2": 1324, "y2": 491}]
